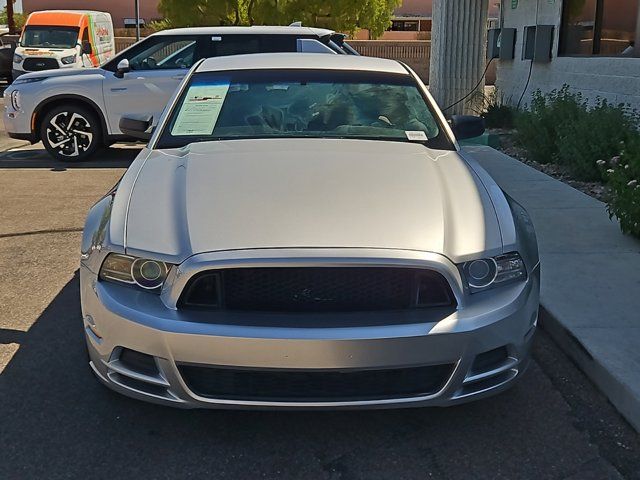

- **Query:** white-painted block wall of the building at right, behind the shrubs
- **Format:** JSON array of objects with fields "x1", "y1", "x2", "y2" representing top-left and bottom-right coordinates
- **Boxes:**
[{"x1": 494, "y1": 0, "x2": 640, "y2": 109}]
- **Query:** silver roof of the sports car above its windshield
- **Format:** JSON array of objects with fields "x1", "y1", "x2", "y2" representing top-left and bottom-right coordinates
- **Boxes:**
[{"x1": 196, "y1": 53, "x2": 409, "y2": 75}]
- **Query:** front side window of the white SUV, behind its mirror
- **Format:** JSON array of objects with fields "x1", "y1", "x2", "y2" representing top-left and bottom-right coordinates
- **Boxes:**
[{"x1": 129, "y1": 36, "x2": 201, "y2": 70}]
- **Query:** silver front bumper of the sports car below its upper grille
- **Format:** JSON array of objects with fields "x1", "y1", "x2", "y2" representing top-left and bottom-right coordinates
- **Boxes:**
[{"x1": 81, "y1": 251, "x2": 539, "y2": 409}]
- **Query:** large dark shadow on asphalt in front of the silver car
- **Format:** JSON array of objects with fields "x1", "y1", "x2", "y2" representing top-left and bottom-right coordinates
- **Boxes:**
[{"x1": 0, "y1": 273, "x2": 628, "y2": 479}]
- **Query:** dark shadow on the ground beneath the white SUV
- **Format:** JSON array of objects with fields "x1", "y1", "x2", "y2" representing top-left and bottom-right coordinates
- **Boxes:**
[{"x1": 0, "y1": 144, "x2": 142, "y2": 171}]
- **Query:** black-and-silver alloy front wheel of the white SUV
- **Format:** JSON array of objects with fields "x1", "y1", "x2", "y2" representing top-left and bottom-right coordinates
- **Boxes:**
[{"x1": 40, "y1": 105, "x2": 102, "y2": 162}]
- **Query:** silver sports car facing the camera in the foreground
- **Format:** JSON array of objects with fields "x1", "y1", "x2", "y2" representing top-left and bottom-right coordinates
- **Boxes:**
[{"x1": 80, "y1": 54, "x2": 540, "y2": 408}]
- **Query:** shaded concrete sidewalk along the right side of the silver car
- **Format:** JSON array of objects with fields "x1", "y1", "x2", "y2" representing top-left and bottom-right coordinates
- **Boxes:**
[{"x1": 465, "y1": 146, "x2": 640, "y2": 431}]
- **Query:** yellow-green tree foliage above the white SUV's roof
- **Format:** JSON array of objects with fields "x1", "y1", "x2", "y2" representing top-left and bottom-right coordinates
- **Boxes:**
[{"x1": 159, "y1": 0, "x2": 401, "y2": 38}]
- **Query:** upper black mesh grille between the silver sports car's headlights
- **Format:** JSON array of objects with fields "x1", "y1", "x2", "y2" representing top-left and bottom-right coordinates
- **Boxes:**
[{"x1": 179, "y1": 267, "x2": 455, "y2": 312}]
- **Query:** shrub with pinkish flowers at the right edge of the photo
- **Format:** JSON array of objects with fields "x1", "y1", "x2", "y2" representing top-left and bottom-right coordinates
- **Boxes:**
[{"x1": 597, "y1": 135, "x2": 640, "y2": 237}]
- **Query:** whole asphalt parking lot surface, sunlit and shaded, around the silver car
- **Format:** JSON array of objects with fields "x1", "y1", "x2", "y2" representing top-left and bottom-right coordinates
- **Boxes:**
[{"x1": 0, "y1": 138, "x2": 640, "y2": 480}]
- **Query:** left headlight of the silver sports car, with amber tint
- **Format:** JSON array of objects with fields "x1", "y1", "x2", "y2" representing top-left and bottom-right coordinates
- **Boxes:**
[{"x1": 99, "y1": 253, "x2": 168, "y2": 291}]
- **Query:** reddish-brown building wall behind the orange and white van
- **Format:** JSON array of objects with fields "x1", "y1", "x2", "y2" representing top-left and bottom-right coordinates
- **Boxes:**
[{"x1": 22, "y1": 0, "x2": 162, "y2": 28}]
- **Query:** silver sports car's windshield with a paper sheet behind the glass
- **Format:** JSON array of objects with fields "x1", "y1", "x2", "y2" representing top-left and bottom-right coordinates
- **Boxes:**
[{"x1": 157, "y1": 69, "x2": 450, "y2": 148}]
